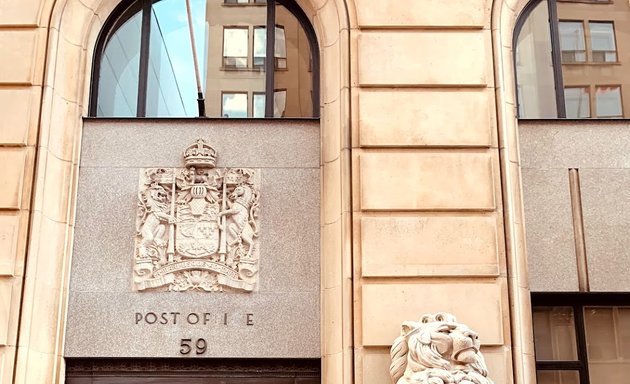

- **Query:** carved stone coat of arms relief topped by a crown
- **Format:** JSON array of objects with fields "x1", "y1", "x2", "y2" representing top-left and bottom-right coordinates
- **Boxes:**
[{"x1": 134, "y1": 139, "x2": 260, "y2": 292}]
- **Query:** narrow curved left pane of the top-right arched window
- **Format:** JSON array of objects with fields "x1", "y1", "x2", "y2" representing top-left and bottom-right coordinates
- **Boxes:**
[{"x1": 515, "y1": 1, "x2": 558, "y2": 119}]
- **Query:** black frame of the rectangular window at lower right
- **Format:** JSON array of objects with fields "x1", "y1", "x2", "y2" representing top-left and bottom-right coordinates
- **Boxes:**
[{"x1": 531, "y1": 292, "x2": 630, "y2": 384}]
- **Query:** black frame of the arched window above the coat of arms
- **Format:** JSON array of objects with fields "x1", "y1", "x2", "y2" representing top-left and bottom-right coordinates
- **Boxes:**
[{"x1": 88, "y1": 0, "x2": 321, "y2": 119}]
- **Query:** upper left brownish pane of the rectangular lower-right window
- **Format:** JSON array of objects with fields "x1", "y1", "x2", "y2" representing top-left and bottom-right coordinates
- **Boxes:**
[{"x1": 533, "y1": 307, "x2": 577, "y2": 361}]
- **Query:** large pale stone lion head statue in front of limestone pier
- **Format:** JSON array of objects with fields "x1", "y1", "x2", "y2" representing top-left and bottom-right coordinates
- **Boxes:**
[{"x1": 389, "y1": 313, "x2": 493, "y2": 384}]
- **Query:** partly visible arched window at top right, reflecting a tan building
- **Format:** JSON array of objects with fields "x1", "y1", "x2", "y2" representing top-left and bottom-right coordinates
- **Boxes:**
[{"x1": 514, "y1": 0, "x2": 630, "y2": 119}]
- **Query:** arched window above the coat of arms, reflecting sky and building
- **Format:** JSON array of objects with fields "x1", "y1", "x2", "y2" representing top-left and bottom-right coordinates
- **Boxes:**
[{"x1": 89, "y1": 0, "x2": 319, "y2": 118}]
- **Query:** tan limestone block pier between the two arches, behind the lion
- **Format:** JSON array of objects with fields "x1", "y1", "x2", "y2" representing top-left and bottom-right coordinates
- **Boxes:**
[{"x1": 351, "y1": 0, "x2": 513, "y2": 384}]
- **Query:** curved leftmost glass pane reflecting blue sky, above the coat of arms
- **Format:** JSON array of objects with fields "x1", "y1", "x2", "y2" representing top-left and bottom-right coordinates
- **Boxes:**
[{"x1": 96, "y1": 12, "x2": 142, "y2": 117}]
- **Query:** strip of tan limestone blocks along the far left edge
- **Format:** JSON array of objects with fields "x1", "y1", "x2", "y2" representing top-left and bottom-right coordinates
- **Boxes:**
[{"x1": 0, "y1": 0, "x2": 46, "y2": 383}]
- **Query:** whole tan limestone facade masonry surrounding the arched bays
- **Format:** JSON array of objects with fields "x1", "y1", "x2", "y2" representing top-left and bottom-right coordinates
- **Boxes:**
[{"x1": 0, "y1": 0, "x2": 628, "y2": 384}]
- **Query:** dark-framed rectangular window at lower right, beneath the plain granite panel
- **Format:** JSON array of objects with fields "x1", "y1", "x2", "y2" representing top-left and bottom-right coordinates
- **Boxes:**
[{"x1": 532, "y1": 293, "x2": 630, "y2": 384}]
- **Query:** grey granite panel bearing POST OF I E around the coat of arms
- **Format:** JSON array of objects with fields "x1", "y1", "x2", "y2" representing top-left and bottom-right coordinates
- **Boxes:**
[{"x1": 65, "y1": 120, "x2": 321, "y2": 358}]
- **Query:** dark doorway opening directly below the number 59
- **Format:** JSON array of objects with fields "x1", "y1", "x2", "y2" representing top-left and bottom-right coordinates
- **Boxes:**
[{"x1": 66, "y1": 358, "x2": 321, "y2": 384}]
